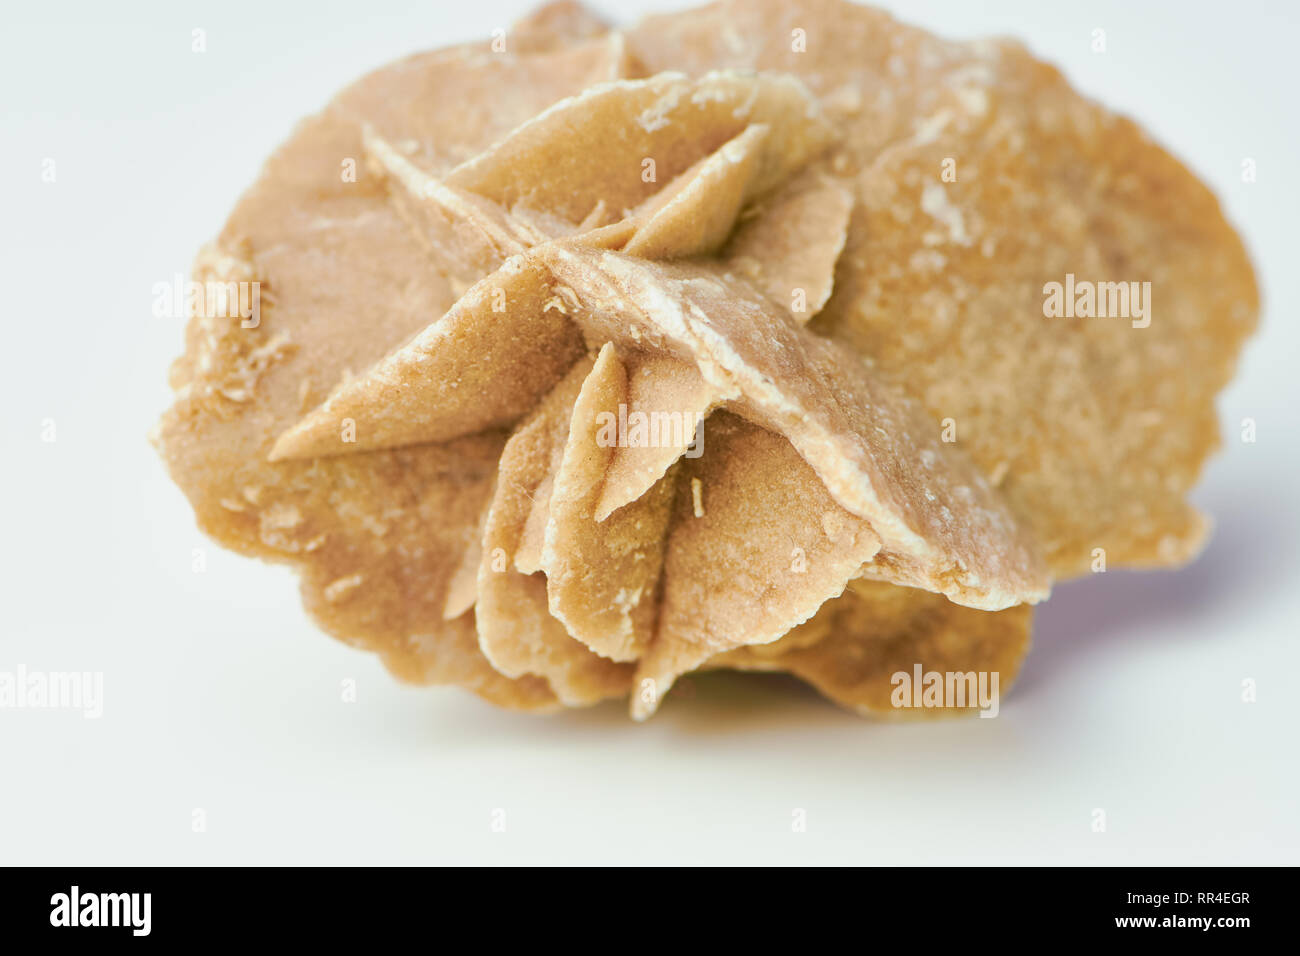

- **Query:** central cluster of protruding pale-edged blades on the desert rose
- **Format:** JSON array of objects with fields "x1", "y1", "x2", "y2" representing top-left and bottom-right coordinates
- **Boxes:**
[{"x1": 263, "y1": 73, "x2": 1048, "y2": 717}]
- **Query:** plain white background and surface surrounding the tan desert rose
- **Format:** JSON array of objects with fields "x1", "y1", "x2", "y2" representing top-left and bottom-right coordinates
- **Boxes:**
[{"x1": 0, "y1": 0, "x2": 1300, "y2": 864}]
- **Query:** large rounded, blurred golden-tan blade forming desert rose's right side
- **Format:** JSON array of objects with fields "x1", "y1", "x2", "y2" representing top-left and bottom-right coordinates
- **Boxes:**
[{"x1": 628, "y1": 0, "x2": 1258, "y2": 576}]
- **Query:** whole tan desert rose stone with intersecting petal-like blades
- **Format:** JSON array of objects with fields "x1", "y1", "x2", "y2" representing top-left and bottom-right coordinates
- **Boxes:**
[{"x1": 157, "y1": 0, "x2": 1257, "y2": 718}]
